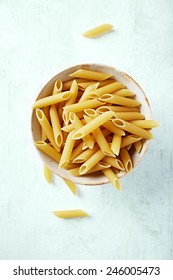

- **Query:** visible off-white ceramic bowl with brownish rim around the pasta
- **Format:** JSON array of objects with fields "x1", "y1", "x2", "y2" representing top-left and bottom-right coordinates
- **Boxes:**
[{"x1": 31, "y1": 64, "x2": 152, "y2": 185}]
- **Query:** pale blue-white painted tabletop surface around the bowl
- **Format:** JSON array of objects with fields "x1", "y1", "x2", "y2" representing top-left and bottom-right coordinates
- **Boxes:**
[{"x1": 0, "y1": 0, "x2": 173, "y2": 259}]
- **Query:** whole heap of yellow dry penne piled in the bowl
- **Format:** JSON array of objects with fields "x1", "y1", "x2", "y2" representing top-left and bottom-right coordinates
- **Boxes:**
[{"x1": 33, "y1": 69, "x2": 158, "y2": 190}]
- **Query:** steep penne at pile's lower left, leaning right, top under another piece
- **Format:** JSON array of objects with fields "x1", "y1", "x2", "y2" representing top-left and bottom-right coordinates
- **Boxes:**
[{"x1": 59, "y1": 131, "x2": 75, "y2": 168}]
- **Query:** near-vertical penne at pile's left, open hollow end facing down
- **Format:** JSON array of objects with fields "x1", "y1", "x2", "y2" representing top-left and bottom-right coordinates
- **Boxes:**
[{"x1": 50, "y1": 105, "x2": 63, "y2": 147}]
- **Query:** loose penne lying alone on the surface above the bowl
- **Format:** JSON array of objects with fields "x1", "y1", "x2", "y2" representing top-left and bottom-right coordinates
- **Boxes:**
[{"x1": 82, "y1": 23, "x2": 113, "y2": 38}]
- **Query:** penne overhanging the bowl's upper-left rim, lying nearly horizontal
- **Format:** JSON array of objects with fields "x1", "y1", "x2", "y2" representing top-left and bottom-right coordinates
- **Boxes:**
[{"x1": 33, "y1": 91, "x2": 73, "y2": 109}]
